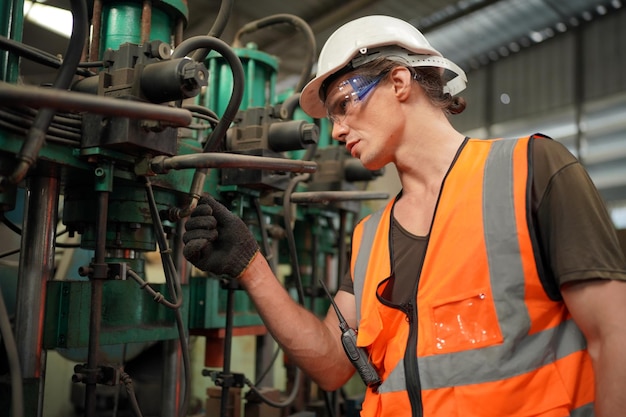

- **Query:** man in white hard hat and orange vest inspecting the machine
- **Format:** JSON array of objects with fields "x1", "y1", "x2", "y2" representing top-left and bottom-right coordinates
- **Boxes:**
[{"x1": 184, "y1": 16, "x2": 626, "y2": 417}]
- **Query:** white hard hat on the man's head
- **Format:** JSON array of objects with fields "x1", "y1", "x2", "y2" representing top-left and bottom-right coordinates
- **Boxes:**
[{"x1": 300, "y1": 15, "x2": 467, "y2": 118}]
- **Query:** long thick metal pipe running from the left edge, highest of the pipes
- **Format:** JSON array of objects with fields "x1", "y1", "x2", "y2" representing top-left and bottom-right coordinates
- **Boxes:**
[{"x1": 0, "y1": 83, "x2": 192, "y2": 126}]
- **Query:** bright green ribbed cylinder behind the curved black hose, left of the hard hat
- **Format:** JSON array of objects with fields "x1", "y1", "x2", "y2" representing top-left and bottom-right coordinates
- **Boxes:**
[{"x1": 203, "y1": 43, "x2": 278, "y2": 116}]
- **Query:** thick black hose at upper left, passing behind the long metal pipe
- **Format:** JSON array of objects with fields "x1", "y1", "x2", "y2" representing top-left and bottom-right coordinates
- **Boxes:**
[{"x1": 9, "y1": 0, "x2": 89, "y2": 184}]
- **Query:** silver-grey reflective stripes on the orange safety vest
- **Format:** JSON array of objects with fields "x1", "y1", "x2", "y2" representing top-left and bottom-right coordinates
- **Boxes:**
[{"x1": 355, "y1": 140, "x2": 586, "y2": 394}]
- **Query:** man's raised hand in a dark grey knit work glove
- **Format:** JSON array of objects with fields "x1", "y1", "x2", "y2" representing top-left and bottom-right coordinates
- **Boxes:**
[{"x1": 183, "y1": 196, "x2": 259, "y2": 278}]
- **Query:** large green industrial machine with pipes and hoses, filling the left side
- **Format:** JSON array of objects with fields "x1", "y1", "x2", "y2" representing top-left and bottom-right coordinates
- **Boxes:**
[{"x1": 0, "y1": 0, "x2": 387, "y2": 417}]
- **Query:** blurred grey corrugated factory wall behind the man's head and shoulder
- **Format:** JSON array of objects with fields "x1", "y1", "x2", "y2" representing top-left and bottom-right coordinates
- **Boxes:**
[{"x1": 452, "y1": 9, "x2": 626, "y2": 226}]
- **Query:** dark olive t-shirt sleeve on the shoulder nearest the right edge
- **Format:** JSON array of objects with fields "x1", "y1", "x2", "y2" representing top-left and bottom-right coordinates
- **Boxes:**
[{"x1": 531, "y1": 139, "x2": 626, "y2": 286}]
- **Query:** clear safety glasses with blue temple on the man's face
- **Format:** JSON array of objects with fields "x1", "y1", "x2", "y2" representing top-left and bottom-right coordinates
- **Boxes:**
[{"x1": 324, "y1": 72, "x2": 387, "y2": 123}]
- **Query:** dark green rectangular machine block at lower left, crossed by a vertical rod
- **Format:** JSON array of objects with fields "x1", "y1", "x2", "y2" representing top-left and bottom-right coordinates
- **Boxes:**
[{"x1": 43, "y1": 280, "x2": 189, "y2": 349}]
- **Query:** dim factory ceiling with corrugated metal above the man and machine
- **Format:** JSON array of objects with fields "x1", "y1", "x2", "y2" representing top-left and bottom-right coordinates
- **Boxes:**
[{"x1": 22, "y1": 0, "x2": 622, "y2": 89}]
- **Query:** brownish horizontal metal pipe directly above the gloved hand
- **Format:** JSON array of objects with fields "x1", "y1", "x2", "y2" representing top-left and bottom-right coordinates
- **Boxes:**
[{"x1": 150, "y1": 152, "x2": 317, "y2": 174}]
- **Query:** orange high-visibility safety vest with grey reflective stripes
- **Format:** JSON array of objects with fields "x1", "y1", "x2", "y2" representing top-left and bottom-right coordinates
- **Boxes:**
[{"x1": 351, "y1": 138, "x2": 594, "y2": 417}]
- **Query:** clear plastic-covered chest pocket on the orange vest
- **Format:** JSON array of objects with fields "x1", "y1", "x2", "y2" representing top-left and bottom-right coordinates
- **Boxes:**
[{"x1": 431, "y1": 289, "x2": 502, "y2": 354}]
